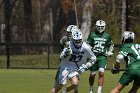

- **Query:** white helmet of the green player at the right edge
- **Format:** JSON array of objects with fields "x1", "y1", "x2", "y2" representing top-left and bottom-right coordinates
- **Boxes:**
[{"x1": 121, "y1": 31, "x2": 135, "y2": 43}]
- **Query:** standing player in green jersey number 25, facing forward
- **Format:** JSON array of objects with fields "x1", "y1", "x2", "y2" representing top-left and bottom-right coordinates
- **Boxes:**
[{"x1": 87, "y1": 20, "x2": 114, "y2": 93}]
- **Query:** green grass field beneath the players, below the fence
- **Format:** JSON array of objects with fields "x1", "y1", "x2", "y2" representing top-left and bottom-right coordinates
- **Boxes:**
[{"x1": 0, "y1": 69, "x2": 140, "y2": 93}]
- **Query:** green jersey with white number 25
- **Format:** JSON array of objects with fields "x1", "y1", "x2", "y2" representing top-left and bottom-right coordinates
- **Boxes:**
[{"x1": 87, "y1": 31, "x2": 113, "y2": 56}]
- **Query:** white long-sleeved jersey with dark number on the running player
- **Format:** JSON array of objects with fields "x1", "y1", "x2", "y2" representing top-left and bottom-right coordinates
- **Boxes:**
[{"x1": 60, "y1": 41, "x2": 96, "y2": 70}]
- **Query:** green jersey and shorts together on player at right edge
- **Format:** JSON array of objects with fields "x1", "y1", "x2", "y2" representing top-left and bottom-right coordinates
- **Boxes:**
[{"x1": 119, "y1": 43, "x2": 140, "y2": 86}]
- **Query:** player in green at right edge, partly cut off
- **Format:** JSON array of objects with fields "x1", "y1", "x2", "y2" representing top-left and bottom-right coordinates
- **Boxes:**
[{"x1": 110, "y1": 31, "x2": 140, "y2": 93}]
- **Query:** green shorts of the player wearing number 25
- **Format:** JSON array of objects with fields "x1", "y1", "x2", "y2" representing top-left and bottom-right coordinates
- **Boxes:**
[{"x1": 90, "y1": 56, "x2": 107, "y2": 71}]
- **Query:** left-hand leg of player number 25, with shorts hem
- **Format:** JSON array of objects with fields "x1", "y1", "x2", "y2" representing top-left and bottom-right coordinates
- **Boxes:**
[{"x1": 89, "y1": 64, "x2": 98, "y2": 93}]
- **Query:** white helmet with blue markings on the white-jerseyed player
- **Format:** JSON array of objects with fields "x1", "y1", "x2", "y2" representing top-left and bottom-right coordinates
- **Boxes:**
[{"x1": 72, "y1": 29, "x2": 83, "y2": 48}]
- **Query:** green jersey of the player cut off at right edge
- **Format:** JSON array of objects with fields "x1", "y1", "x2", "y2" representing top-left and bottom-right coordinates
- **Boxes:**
[{"x1": 119, "y1": 43, "x2": 140, "y2": 66}]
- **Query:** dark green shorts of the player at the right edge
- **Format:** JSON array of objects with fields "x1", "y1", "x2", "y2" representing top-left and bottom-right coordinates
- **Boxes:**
[{"x1": 119, "y1": 68, "x2": 140, "y2": 86}]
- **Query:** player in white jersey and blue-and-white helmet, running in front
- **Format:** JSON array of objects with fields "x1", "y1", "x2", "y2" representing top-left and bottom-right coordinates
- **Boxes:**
[{"x1": 50, "y1": 31, "x2": 96, "y2": 93}]
